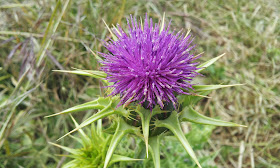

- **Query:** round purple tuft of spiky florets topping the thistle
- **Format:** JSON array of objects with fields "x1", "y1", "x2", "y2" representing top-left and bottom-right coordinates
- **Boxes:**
[{"x1": 101, "y1": 15, "x2": 199, "y2": 108}]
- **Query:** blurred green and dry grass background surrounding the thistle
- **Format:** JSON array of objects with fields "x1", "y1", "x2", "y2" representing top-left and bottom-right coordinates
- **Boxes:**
[{"x1": 0, "y1": 0, "x2": 280, "y2": 168}]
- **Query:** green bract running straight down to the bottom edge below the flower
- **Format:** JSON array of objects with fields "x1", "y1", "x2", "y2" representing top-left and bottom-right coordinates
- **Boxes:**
[{"x1": 149, "y1": 135, "x2": 161, "y2": 168}]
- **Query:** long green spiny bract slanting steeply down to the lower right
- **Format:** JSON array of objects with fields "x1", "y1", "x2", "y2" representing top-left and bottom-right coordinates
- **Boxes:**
[{"x1": 155, "y1": 111, "x2": 201, "y2": 168}]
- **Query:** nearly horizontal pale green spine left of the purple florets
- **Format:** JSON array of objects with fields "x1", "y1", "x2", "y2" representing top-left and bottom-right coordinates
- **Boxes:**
[{"x1": 53, "y1": 69, "x2": 107, "y2": 79}]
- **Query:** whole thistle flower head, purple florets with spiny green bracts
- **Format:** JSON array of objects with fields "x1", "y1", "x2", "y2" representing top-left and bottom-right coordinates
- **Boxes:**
[{"x1": 47, "y1": 15, "x2": 244, "y2": 168}]
